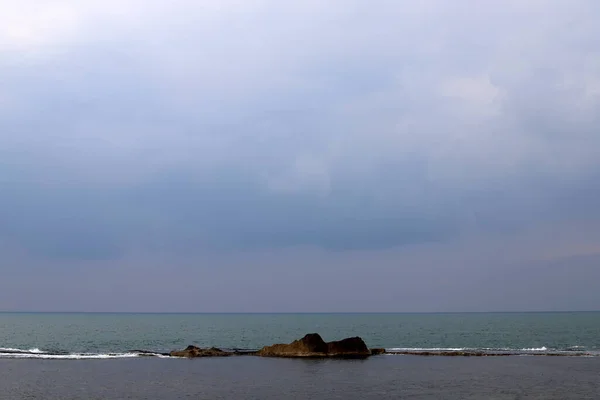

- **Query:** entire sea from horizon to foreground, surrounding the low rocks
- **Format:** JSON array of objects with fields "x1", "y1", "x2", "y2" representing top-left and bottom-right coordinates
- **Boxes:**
[{"x1": 0, "y1": 312, "x2": 600, "y2": 400}]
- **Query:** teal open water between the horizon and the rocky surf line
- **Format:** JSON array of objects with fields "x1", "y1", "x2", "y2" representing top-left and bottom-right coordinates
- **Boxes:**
[{"x1": 0, "y1": 312, "x2": 600, "y2": 358}]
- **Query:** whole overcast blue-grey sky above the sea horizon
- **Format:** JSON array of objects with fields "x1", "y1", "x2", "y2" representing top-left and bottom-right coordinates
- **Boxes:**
[{"x1": 0, "y1": 0, "x2": 600, "y2": 312}]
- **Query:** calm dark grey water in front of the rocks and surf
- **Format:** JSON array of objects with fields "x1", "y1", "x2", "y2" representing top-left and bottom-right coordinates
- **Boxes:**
[{"x1": 0, "y1": 356, "x2": 600, "y2": 400}]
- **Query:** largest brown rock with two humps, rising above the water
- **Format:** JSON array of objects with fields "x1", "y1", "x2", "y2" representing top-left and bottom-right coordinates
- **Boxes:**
[{"x1": 257, "y1": 333, "x2": 371, "y2": 358}]
